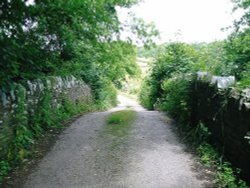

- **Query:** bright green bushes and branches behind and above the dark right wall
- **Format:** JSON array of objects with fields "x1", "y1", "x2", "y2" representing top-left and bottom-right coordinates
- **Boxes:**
[{"x1": 140, "y1": 0, "x2": 250, "y2": 114}]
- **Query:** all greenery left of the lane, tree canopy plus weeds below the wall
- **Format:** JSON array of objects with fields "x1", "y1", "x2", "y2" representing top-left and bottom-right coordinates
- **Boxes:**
[{"x1": 0, "y1": 0, "x2": 158, "y2": 182}]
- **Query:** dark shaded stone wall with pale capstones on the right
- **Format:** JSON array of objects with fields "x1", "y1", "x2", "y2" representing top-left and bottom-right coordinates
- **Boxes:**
[{"x1": 191, "y1": 72, "x2": 250, "y2": 182}]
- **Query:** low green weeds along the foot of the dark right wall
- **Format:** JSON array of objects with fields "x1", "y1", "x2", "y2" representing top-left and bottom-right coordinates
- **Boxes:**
[{"x1": 179, "y1": 122, "x2": 248, "y2": 188}]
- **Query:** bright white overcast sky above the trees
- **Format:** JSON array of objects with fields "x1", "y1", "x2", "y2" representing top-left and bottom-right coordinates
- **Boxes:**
[{"x1": 119, "y1": 0, "x2": 243, "y2": 43}]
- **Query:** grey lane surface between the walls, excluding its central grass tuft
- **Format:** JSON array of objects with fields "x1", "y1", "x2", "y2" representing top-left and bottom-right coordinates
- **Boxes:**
[{"x1": 23, "y1": 96, "x2": 213, "y2": 188}]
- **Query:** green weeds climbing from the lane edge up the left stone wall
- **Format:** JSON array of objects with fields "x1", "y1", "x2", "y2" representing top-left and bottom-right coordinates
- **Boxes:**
[{"x1": 0, "y1": 88, "x2": 109, "y2": 185}]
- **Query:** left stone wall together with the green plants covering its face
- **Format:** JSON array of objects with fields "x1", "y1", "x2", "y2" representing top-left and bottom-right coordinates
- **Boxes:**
[{"x1": 0, "y1": 76, "x2": 92, "y2": 182}]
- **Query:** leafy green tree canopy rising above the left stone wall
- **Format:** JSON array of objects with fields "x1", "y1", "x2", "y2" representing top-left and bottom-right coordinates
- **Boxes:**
[{"x1": 0, "y1": 0, "x2": 157, "y2": 103}]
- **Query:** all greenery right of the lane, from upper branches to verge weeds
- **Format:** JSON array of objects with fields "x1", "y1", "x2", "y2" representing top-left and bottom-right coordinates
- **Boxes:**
[{"x1": 139, "y1": 0, "x2": 250, "y2": 187}]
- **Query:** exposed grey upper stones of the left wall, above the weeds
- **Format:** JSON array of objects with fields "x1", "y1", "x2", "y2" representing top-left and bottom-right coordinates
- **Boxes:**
[{"x1": 0, "y1": 76, "x2": 92, "y2": 132}]
